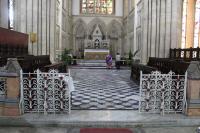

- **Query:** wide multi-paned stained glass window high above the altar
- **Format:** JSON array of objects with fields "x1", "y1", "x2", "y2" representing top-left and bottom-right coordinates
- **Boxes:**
[{"x1": 81, "y1": 0, "x2": 114, "y2": 15}]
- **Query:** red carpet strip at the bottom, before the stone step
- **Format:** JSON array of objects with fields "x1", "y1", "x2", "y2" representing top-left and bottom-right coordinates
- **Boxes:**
[{"x1": 80, "y1": 128, "x2": 133, "y2": 133}]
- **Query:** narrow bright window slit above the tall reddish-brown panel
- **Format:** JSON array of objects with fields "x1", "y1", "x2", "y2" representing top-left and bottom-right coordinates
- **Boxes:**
[{"x1": 8, "y1": 0, "x2": 14, "y2": 29}]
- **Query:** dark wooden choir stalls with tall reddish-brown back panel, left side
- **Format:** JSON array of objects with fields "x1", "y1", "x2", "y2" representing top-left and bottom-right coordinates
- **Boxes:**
[{"x1": 0, "y1": 27, "x2": 66, "y2": 72}]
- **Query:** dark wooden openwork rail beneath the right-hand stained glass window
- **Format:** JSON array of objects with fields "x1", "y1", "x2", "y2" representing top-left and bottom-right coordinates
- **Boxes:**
[{"x1": 170, "y1": 47, "x2": 200, "y2": 62}]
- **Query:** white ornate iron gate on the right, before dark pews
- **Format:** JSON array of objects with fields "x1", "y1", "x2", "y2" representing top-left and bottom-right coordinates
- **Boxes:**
[{"x1": 139, "y1": 71, "x2": 187, "y2": 114}]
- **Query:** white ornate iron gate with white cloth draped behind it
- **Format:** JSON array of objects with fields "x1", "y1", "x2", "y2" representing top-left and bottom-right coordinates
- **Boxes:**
[{"x1": 20, "y1": 70, "x2": 71, "y2": 114}]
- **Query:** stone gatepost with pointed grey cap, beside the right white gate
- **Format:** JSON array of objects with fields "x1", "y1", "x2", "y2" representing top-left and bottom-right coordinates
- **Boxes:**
[{"x1": 187, "y1": 61, "x2": 200, "y2": 116}]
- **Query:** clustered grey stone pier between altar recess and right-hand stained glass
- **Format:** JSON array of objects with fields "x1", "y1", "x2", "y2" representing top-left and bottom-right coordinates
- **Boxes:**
[{"x1": 141, "y1": 0, "x2": 182, "y2": 63}]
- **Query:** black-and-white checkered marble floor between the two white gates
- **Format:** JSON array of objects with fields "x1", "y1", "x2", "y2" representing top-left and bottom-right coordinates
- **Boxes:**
[{"x1": 71, "y1": 69, "x2": 139, "y2": 110}]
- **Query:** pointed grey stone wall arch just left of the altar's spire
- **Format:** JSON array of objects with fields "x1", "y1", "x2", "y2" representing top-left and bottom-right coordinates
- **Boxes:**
[{"x1": 73, "y1": 19, "x2": 87, "y2": 58}]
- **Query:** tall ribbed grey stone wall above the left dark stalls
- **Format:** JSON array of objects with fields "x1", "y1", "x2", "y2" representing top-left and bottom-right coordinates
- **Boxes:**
[{"x1": 14, "y1": 0, "x2": 72, "y2": 62}]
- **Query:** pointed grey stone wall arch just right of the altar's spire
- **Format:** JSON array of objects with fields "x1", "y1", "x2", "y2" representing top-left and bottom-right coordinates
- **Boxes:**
[{"x1": 108, "y1": 20, "x2": 122, "y2": 57}]
